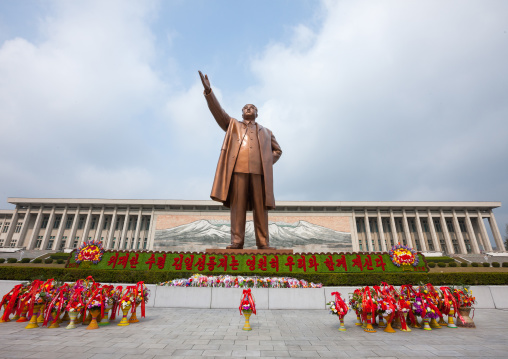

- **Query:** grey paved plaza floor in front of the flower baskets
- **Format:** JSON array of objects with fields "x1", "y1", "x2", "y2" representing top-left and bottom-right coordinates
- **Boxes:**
[{"x1": 0, "y1": 308, "x2": 508, "y2": 359}]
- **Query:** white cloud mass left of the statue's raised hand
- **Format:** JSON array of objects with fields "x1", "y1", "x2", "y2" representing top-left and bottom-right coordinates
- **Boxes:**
[{"x1": 0, "y1": 1, "x2": 168, "y2": 202}]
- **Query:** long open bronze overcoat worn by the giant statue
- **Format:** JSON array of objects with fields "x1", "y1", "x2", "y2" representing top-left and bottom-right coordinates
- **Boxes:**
[{"x1": 205, "y1": 91, "x2": 282, "y2": 210}]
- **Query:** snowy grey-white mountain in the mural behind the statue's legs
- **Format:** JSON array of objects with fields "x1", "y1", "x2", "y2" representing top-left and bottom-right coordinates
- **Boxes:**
[{"x1": 154, "y1": 219, "x2": 353, "y2": 252}]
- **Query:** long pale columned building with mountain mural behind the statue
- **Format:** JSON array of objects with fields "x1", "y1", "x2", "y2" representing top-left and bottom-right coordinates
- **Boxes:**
[{"x1": 0, "y1": 198, "x2": 505, "y2": 254}]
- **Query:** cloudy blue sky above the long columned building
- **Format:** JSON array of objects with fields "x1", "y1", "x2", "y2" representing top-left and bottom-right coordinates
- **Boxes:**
[{"x1": 0, "y1": 0, "x2": 508, "y2": 248}]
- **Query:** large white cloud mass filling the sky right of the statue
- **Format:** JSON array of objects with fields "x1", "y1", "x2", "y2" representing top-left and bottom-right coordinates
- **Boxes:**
[{"x1": 249, "y1": 1, "x2": 508, "y2": 208}]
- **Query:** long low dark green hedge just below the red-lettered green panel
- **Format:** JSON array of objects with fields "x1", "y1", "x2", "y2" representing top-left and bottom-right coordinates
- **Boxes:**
[{"x1": 0, "y1": 266, "x2": 508, "y2": 286}]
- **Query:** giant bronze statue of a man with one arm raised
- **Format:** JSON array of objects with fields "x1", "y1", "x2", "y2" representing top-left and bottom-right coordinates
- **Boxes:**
[{"x1": 199, "y1": 71, "x2": 282, "y2": 249}]
